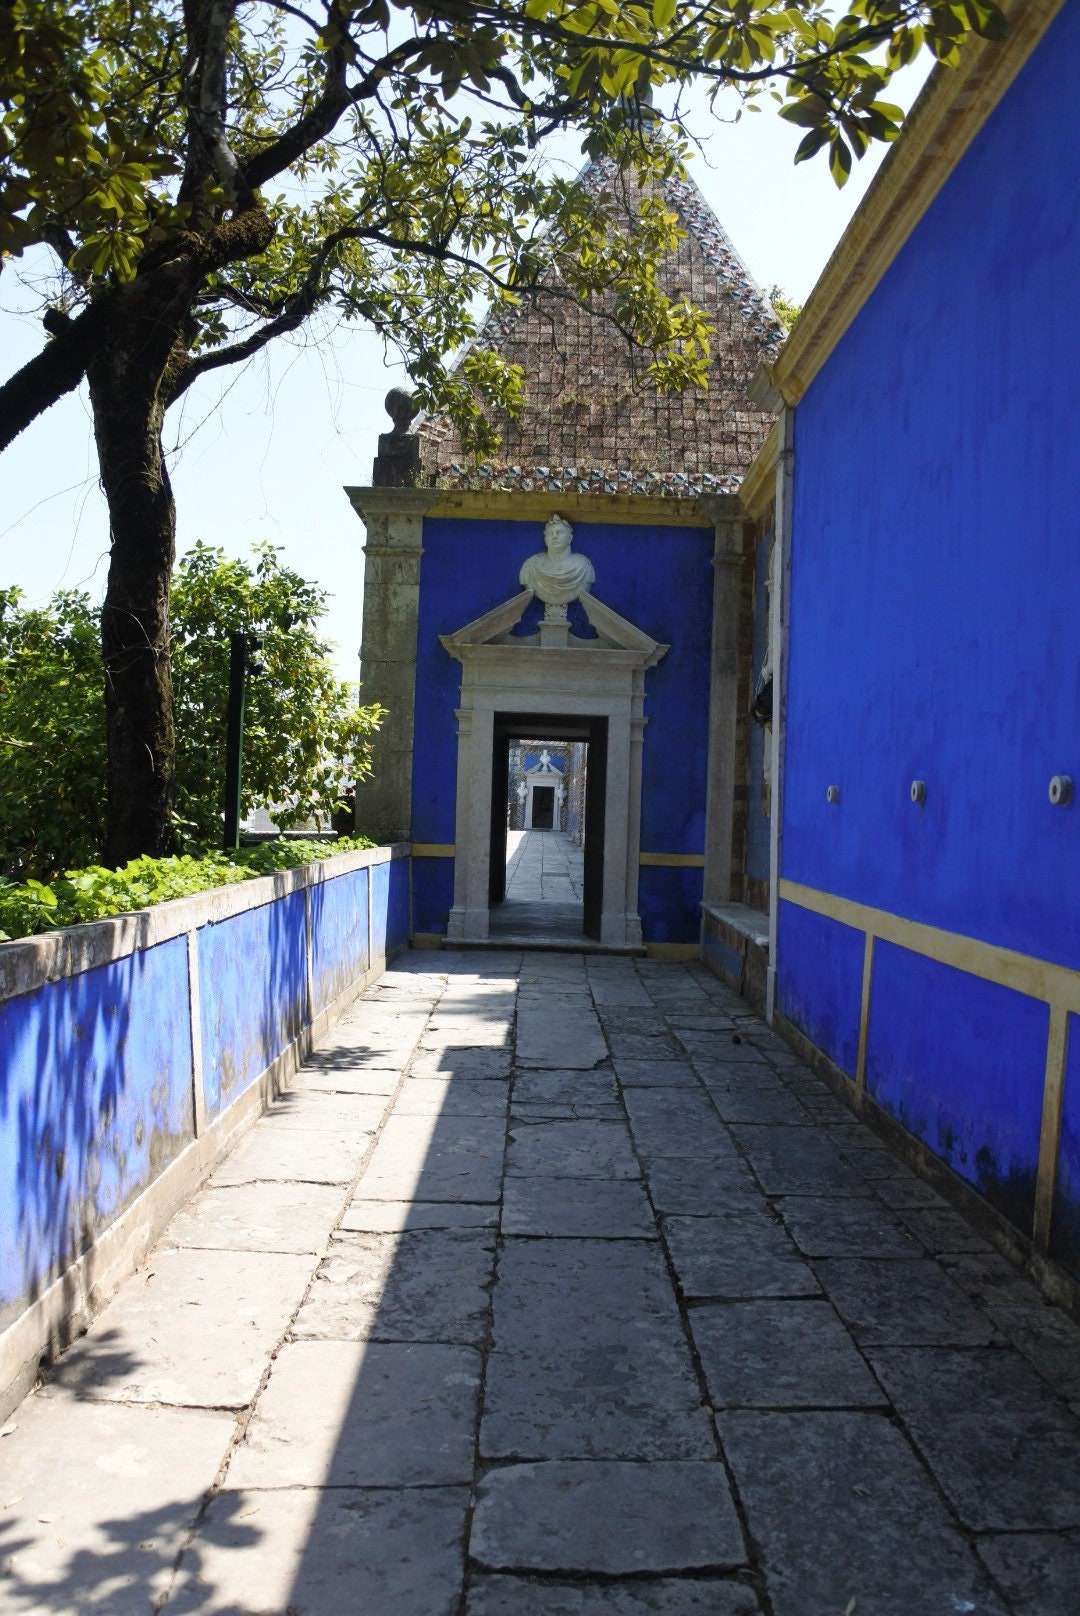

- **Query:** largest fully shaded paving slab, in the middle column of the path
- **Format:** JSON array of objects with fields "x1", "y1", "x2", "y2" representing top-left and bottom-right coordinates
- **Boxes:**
[{"x1": 480, "y1": 1238, "x2": 715, "y2": 1459}]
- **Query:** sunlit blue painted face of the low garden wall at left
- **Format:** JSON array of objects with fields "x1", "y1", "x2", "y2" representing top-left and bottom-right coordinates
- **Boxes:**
[{"x1": 0, "y1": 858, "x2": 409, "y2": 1328}]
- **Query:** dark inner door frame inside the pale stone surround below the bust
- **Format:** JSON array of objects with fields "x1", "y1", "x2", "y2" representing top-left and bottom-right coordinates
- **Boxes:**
[{"x1": 488, "y1": 713, "x2": 607, "y2": 942}]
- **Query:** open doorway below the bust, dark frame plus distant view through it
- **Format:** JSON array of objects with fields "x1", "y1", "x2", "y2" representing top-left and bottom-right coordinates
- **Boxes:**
[{"x1": 488, "y1": 713, "x2": 608, "y2": 942}]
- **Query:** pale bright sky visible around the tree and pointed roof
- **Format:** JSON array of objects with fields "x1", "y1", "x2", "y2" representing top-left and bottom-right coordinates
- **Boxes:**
[{"x1": 0, "y1": 66, "x2": 925, "y2": 680}]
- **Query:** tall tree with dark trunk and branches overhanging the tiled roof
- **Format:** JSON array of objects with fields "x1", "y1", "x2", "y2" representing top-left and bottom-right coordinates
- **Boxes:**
[{"x1": 0, "y1": 0, "x2": 1004, "y2": 863}]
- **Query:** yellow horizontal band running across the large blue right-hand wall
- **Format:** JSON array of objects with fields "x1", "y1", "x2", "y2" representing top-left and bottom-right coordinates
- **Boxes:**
[{"x1": 778, "y1": 881, "x2": 1080, "y2": 1013}]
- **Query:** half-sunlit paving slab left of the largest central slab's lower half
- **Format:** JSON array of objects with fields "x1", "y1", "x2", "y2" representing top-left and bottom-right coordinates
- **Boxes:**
[{"x1": 226, "y1": 1341, "x2": 480, "y2": 1488}]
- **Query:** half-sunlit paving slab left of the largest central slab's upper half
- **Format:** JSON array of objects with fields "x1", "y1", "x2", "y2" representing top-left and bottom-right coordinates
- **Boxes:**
[{"x1": 293, "y1": 1230, "x2": 495, "y2": 1346}]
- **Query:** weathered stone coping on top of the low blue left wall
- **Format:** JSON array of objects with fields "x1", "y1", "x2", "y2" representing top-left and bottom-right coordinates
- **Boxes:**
[{"x1": 0, "y1": 842, "x2": 409, "y2": 1005}]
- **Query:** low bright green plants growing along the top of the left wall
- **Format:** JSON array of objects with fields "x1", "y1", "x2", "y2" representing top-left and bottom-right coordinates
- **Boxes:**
[{"x1": 0, "y1": 837, "x2": 375, "y2": 942}]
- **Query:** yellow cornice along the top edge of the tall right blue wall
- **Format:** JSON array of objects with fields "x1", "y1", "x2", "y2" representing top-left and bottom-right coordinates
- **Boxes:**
[{"x1": 766, "y1": 0, "x2": 1064, "y2": 404}]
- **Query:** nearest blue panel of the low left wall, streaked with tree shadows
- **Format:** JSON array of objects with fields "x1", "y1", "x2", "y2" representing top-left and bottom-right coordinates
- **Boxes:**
[{"x1": 0, "y1": 937, "x2": 194, "y2": 1328}]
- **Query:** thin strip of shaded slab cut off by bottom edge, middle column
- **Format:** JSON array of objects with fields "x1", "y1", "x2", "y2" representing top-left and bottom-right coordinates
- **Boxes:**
[{"x1": 466, "y1": 1574, "x2": 759, "y2": 1616}]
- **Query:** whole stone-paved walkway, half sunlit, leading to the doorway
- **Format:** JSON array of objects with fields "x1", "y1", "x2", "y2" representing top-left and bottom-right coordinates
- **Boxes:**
[{"x1": 0, "y1": 953, "x2": 1080, "y2": 1616}]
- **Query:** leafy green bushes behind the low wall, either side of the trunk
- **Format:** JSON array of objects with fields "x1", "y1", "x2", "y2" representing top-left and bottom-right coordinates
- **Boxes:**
[{"x1": 0, "y1": 545, "x2": 378, "y2": 879}]
